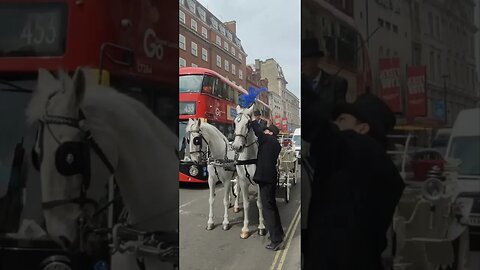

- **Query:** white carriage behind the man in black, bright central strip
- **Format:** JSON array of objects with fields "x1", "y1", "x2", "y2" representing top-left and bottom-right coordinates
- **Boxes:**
[{"x1": 277, "y1": 146, "x2": 298, "y2": 203}]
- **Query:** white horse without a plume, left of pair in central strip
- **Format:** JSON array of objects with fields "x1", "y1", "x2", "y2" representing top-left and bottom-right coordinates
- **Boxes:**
[{"x1": 186, "y1": 119, "x2": 238, "y2": 230}]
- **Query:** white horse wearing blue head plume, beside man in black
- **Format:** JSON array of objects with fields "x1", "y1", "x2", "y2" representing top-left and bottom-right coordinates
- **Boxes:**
[{"x1": 232, "y1": 105, "x2": 266, "y2": 239}]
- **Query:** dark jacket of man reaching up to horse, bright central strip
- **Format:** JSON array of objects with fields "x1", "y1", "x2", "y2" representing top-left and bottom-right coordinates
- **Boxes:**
[{"x1": 250, "y1": 121, "x2": 282, "y2": 183}]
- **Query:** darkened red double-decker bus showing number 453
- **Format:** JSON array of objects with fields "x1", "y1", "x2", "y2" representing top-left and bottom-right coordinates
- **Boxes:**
[{"x1": 0, "y1": 0, "x2": 178, "y2": 269}]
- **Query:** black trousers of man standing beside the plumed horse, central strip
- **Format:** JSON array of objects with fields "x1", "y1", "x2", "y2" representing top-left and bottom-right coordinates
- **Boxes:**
[{"x1": 258, "y1": 182, "x2": 283, "y2": 242}]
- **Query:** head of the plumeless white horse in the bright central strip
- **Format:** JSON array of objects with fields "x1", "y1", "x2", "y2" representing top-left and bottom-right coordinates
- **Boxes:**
[{"x1": 186, "y1": 119, "x2": 208, "y2": 164}]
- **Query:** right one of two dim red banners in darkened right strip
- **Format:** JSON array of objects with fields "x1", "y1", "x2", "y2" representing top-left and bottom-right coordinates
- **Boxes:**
[{"x1": 407, "y1": 66, "x2": 427, "y2": 117}]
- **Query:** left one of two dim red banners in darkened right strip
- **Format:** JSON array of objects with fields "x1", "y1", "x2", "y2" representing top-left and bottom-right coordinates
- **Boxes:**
[{"x1": 379, "y1": 58, "x2": 402, "y2": 113}]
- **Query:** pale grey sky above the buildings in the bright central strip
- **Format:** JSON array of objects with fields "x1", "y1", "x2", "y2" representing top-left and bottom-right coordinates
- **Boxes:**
[{"x1": 198, "y1": 0, "x2": 300, "y2": 97}]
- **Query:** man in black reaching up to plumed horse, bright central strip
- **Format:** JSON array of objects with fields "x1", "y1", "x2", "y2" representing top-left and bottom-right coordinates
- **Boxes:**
[{"x1": 250, "y1": 119, "x2": 283, "y2": 250}]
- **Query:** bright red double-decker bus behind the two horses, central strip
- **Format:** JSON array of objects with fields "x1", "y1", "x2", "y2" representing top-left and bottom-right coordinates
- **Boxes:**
[{"x1": 179, "y1": 67, "x2": 268, "y2": 183}]
